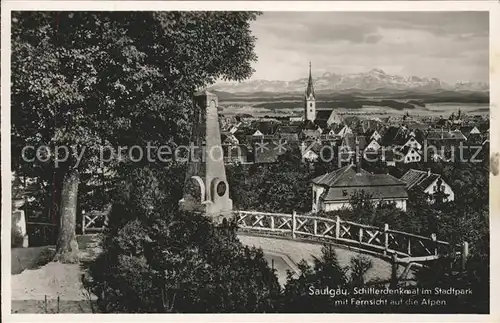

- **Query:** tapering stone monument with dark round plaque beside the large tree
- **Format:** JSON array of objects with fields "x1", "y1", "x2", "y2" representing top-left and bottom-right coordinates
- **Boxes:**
[{"x1": 179, "y1": 91, "x2": 233, "y2": 222}]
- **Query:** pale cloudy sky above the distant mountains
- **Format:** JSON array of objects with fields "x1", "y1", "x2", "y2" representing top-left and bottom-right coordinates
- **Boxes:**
[{"x1": 251, "y1": 12, "x2": 489, "y2": 83}]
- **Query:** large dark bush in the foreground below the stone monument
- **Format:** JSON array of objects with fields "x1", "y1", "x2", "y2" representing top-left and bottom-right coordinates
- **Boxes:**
[{"x1": 84, "y1": 169, "x2": 280, "y2": 313}]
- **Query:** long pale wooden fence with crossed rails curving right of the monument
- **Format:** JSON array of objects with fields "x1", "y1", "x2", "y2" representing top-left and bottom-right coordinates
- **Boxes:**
[{"x1": 235, "y1": 211, "x2": 468, "y2": 262}]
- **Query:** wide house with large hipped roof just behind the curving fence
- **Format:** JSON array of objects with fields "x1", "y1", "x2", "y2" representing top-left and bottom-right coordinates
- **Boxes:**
[{"x1": 311, "y1": 162, "x2": 408, "y2": 212}]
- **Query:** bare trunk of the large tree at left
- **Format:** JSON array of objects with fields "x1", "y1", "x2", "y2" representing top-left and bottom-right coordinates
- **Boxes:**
[{"x1": 54, "y1": 169, "x2": 80, "y2": 263}]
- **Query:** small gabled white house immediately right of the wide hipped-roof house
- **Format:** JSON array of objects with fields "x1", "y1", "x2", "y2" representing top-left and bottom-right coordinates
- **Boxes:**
[{"x1": 400, "y1": 169, "x2": 455, "y2": 202}]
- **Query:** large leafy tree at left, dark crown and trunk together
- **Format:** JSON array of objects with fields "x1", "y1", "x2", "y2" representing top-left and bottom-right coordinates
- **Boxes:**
[{"x1": 11, "y1": 12, "x2": 257, "y2": 261}]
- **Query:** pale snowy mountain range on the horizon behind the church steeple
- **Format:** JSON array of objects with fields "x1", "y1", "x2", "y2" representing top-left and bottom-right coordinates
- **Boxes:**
[{"x1": 209, "y1": 68, "x2": 489, "y2": 94}]
